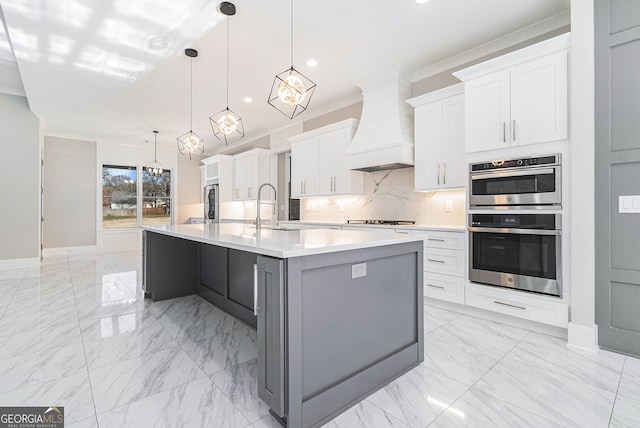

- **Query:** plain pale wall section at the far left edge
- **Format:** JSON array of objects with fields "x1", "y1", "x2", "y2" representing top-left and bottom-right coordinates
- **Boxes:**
[{"x1": 0, "y1": 94, "x2": 40, "y2": 260}]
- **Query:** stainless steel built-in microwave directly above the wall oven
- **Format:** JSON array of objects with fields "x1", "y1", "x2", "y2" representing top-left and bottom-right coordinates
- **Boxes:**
[{"x1": 469, "y1": 154, "x2": 562, "y2": 209}]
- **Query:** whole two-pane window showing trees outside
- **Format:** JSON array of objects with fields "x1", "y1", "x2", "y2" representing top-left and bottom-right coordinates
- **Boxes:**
[{"x1": 102, "y1": 165, "x2": 172, "y2": 229}]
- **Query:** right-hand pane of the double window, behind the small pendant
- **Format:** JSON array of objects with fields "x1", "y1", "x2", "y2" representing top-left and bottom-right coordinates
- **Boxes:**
[{"x1": 142, "y1": 170, "x2": 171, "y2": 225}]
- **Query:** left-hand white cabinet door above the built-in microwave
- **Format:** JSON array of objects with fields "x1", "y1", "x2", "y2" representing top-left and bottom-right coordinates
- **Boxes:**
[{"x1": 465, "y1": 70, "x2": 510, "y2": 153}]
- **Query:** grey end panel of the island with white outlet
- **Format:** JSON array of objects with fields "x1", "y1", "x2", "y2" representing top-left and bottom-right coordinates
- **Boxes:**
[{"x1": 287, "y1": 243, "x2": 424, "y2": 428}]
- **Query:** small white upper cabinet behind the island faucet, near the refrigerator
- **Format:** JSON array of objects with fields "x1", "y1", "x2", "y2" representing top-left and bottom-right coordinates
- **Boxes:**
[{"x1": 233, "y1": 149, "x2": 272, "y2": 201}]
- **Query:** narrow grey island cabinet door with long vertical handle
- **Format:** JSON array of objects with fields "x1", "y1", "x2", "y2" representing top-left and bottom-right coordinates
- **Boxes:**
[{"x1": 254, "y1": 256, "x2": 285, "y2": 416}]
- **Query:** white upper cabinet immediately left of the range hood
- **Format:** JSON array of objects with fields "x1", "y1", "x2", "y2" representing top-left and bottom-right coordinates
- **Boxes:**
[{"x1": 289, "y1": 119, "x2": 364, "y2": 198}]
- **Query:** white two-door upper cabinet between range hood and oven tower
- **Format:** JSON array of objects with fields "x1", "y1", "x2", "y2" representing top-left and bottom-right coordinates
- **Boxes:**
[{"x1": 407, "y1": 84, "x2": 466, "y2": 191}]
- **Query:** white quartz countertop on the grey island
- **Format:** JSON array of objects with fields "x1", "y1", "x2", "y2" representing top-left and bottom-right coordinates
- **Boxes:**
[{"x1": 143, "y1": 223, "x2": 421, "y2": 258}]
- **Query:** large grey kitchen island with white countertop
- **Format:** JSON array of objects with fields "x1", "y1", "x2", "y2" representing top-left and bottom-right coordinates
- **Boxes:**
[{"x1": 143, "y1": 223, "x2": 424, "y2": 428}]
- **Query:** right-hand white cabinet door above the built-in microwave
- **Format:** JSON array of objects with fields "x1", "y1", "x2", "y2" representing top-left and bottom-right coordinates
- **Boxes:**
[{"x1": 511, "y1": 52, "x2": 568, "y2": 145}]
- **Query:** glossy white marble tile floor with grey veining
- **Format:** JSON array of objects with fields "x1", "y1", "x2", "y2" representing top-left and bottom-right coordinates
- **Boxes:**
[{"x1": 0, "y1": 252, "x2": 640, "y2": 428}]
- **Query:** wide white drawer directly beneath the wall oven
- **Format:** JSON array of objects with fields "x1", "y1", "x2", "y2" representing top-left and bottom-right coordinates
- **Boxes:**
[{"x1": 465, "y1": 283, "x2": 569, "y2": 328}]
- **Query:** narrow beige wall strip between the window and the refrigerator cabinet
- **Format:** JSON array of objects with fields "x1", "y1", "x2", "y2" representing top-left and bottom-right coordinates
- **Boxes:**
[{"x1": 174, "y1": 155, "x2": 204, "y2": 224}]
